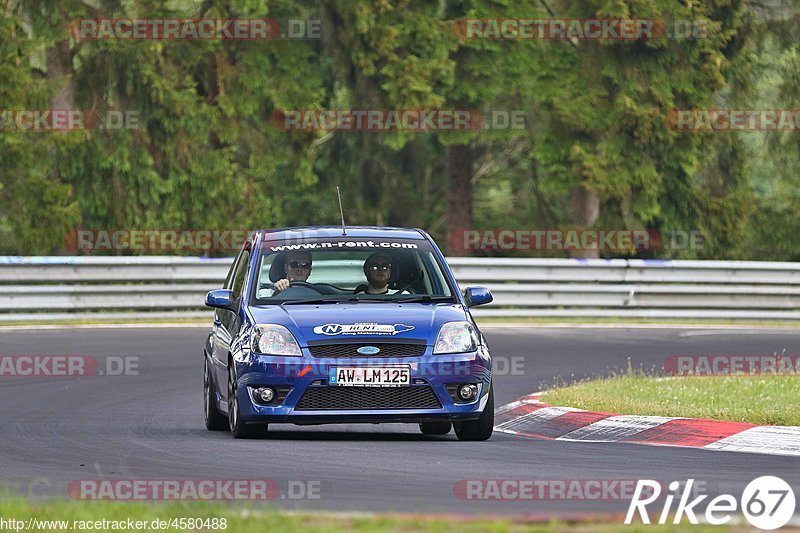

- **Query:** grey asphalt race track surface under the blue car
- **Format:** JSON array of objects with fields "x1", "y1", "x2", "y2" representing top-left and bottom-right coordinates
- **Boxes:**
[{"x1": 0, "y1": 325, "x2": 800, "y2": 515}]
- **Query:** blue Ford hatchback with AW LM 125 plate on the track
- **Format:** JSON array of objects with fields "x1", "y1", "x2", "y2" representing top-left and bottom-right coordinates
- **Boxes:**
[{"x1": 204, "y1": 227, "x2": 494, "y2": 441}]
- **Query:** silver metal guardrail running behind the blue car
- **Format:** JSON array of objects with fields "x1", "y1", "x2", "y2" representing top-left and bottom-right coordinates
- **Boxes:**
[{"x1": 0, "y1": 256, "x2": 800, "y2": 322}]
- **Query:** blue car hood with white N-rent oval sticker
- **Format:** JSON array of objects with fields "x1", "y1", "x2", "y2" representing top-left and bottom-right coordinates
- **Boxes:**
[{"x1": 250, "y1": 303, "x2": 467, "y2": 346}]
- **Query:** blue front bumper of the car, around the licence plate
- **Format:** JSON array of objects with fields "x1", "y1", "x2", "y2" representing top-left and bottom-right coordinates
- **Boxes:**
[{"x1": 235, "y1": 347, "x2": 491, "y2": 424}]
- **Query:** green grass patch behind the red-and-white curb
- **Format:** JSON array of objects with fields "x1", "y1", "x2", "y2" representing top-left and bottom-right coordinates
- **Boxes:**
[{"x1": 542, "y1": 372, "x2": 800, "y2": 426}]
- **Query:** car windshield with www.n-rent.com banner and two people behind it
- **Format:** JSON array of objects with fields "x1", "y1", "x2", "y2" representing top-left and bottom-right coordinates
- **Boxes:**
[{"x1": 251, "y1": 237, "x2": 453, "y2": 305}]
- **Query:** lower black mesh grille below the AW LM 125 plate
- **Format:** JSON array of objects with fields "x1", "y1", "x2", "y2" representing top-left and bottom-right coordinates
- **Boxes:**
[{"x1": 295, "y1": 386, "x2": 442, "y2": 411}]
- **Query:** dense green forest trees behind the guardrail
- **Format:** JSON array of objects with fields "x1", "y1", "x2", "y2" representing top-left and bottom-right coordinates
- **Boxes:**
[{"x1": 0, "y1": 0, "x2": 800, "y2": 260}]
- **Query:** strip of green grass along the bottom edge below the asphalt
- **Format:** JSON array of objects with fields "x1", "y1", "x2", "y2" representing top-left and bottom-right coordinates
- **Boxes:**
[{"x1": 0, "y1": 498, "x2": 744, "y2": 533}]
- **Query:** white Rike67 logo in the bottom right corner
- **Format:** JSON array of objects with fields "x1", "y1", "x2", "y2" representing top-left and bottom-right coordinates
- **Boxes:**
[{"x1": 625, "y1": 476, "x2": 795, "y2": 530}]
